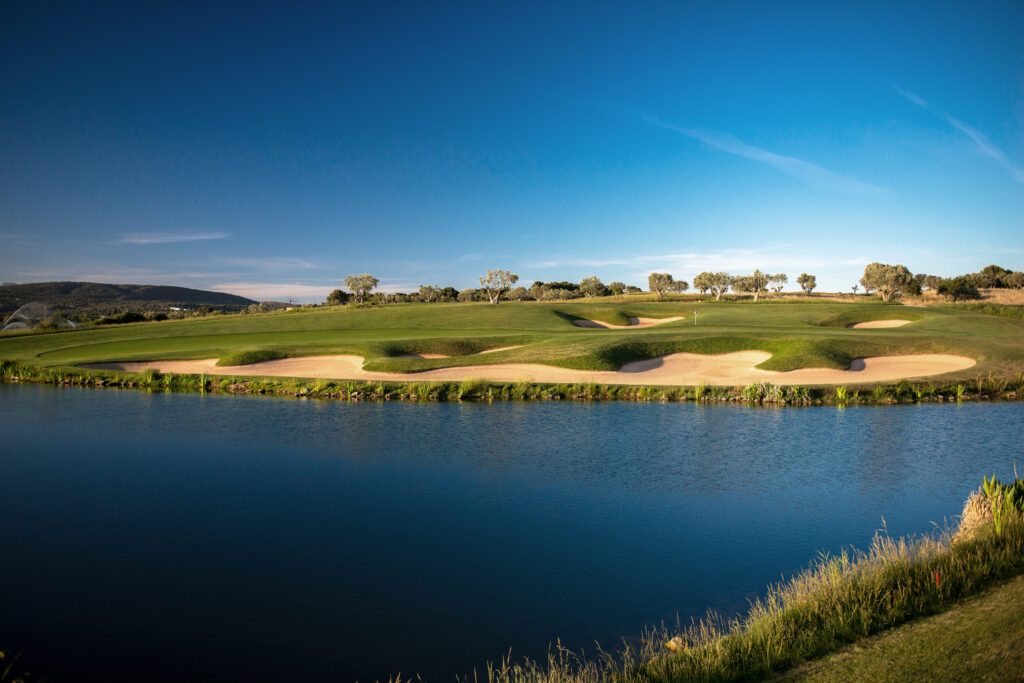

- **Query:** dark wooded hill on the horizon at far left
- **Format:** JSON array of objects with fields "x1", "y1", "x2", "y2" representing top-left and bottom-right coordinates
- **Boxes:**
[{"x1": 0, "y1": 283, "x2": 257, "y2": 315}]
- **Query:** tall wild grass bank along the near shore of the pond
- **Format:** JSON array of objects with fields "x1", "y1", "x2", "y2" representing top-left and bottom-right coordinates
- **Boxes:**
[{"x1": 468, "y1": 483, "x2": 1024, "y2": 683}]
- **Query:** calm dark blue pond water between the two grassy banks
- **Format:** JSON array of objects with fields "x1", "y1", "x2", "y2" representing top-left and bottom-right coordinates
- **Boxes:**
[{"x1": 0, "y1": 385, "x2": 1024, "y2": 681}]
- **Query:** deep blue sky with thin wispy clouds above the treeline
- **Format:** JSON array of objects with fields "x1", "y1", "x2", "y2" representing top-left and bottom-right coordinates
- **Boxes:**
[{"x1": 0, "y1": 1, "x2": 1024, "y2": 301}]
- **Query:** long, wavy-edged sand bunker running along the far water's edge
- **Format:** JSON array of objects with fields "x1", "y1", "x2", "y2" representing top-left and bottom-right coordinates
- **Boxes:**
[{"x1": 82, "y1": 351, "x2": 975, "y2": 386}]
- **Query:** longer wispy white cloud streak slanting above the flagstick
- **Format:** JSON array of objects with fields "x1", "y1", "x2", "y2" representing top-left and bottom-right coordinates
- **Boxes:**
[{"x1": 644, "y1": 117, "x2": 889, "y2": 195}]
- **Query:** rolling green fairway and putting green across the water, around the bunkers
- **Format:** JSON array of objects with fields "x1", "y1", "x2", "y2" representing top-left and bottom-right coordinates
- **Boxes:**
[{"x1": 0, "y1": 301, "x2": 1024, "y2": 381}]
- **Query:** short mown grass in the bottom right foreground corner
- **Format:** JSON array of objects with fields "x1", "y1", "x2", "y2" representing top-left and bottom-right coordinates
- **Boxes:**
[{"x1": 772, "y1": 577, "x2": 1024, "y2": 683}]
